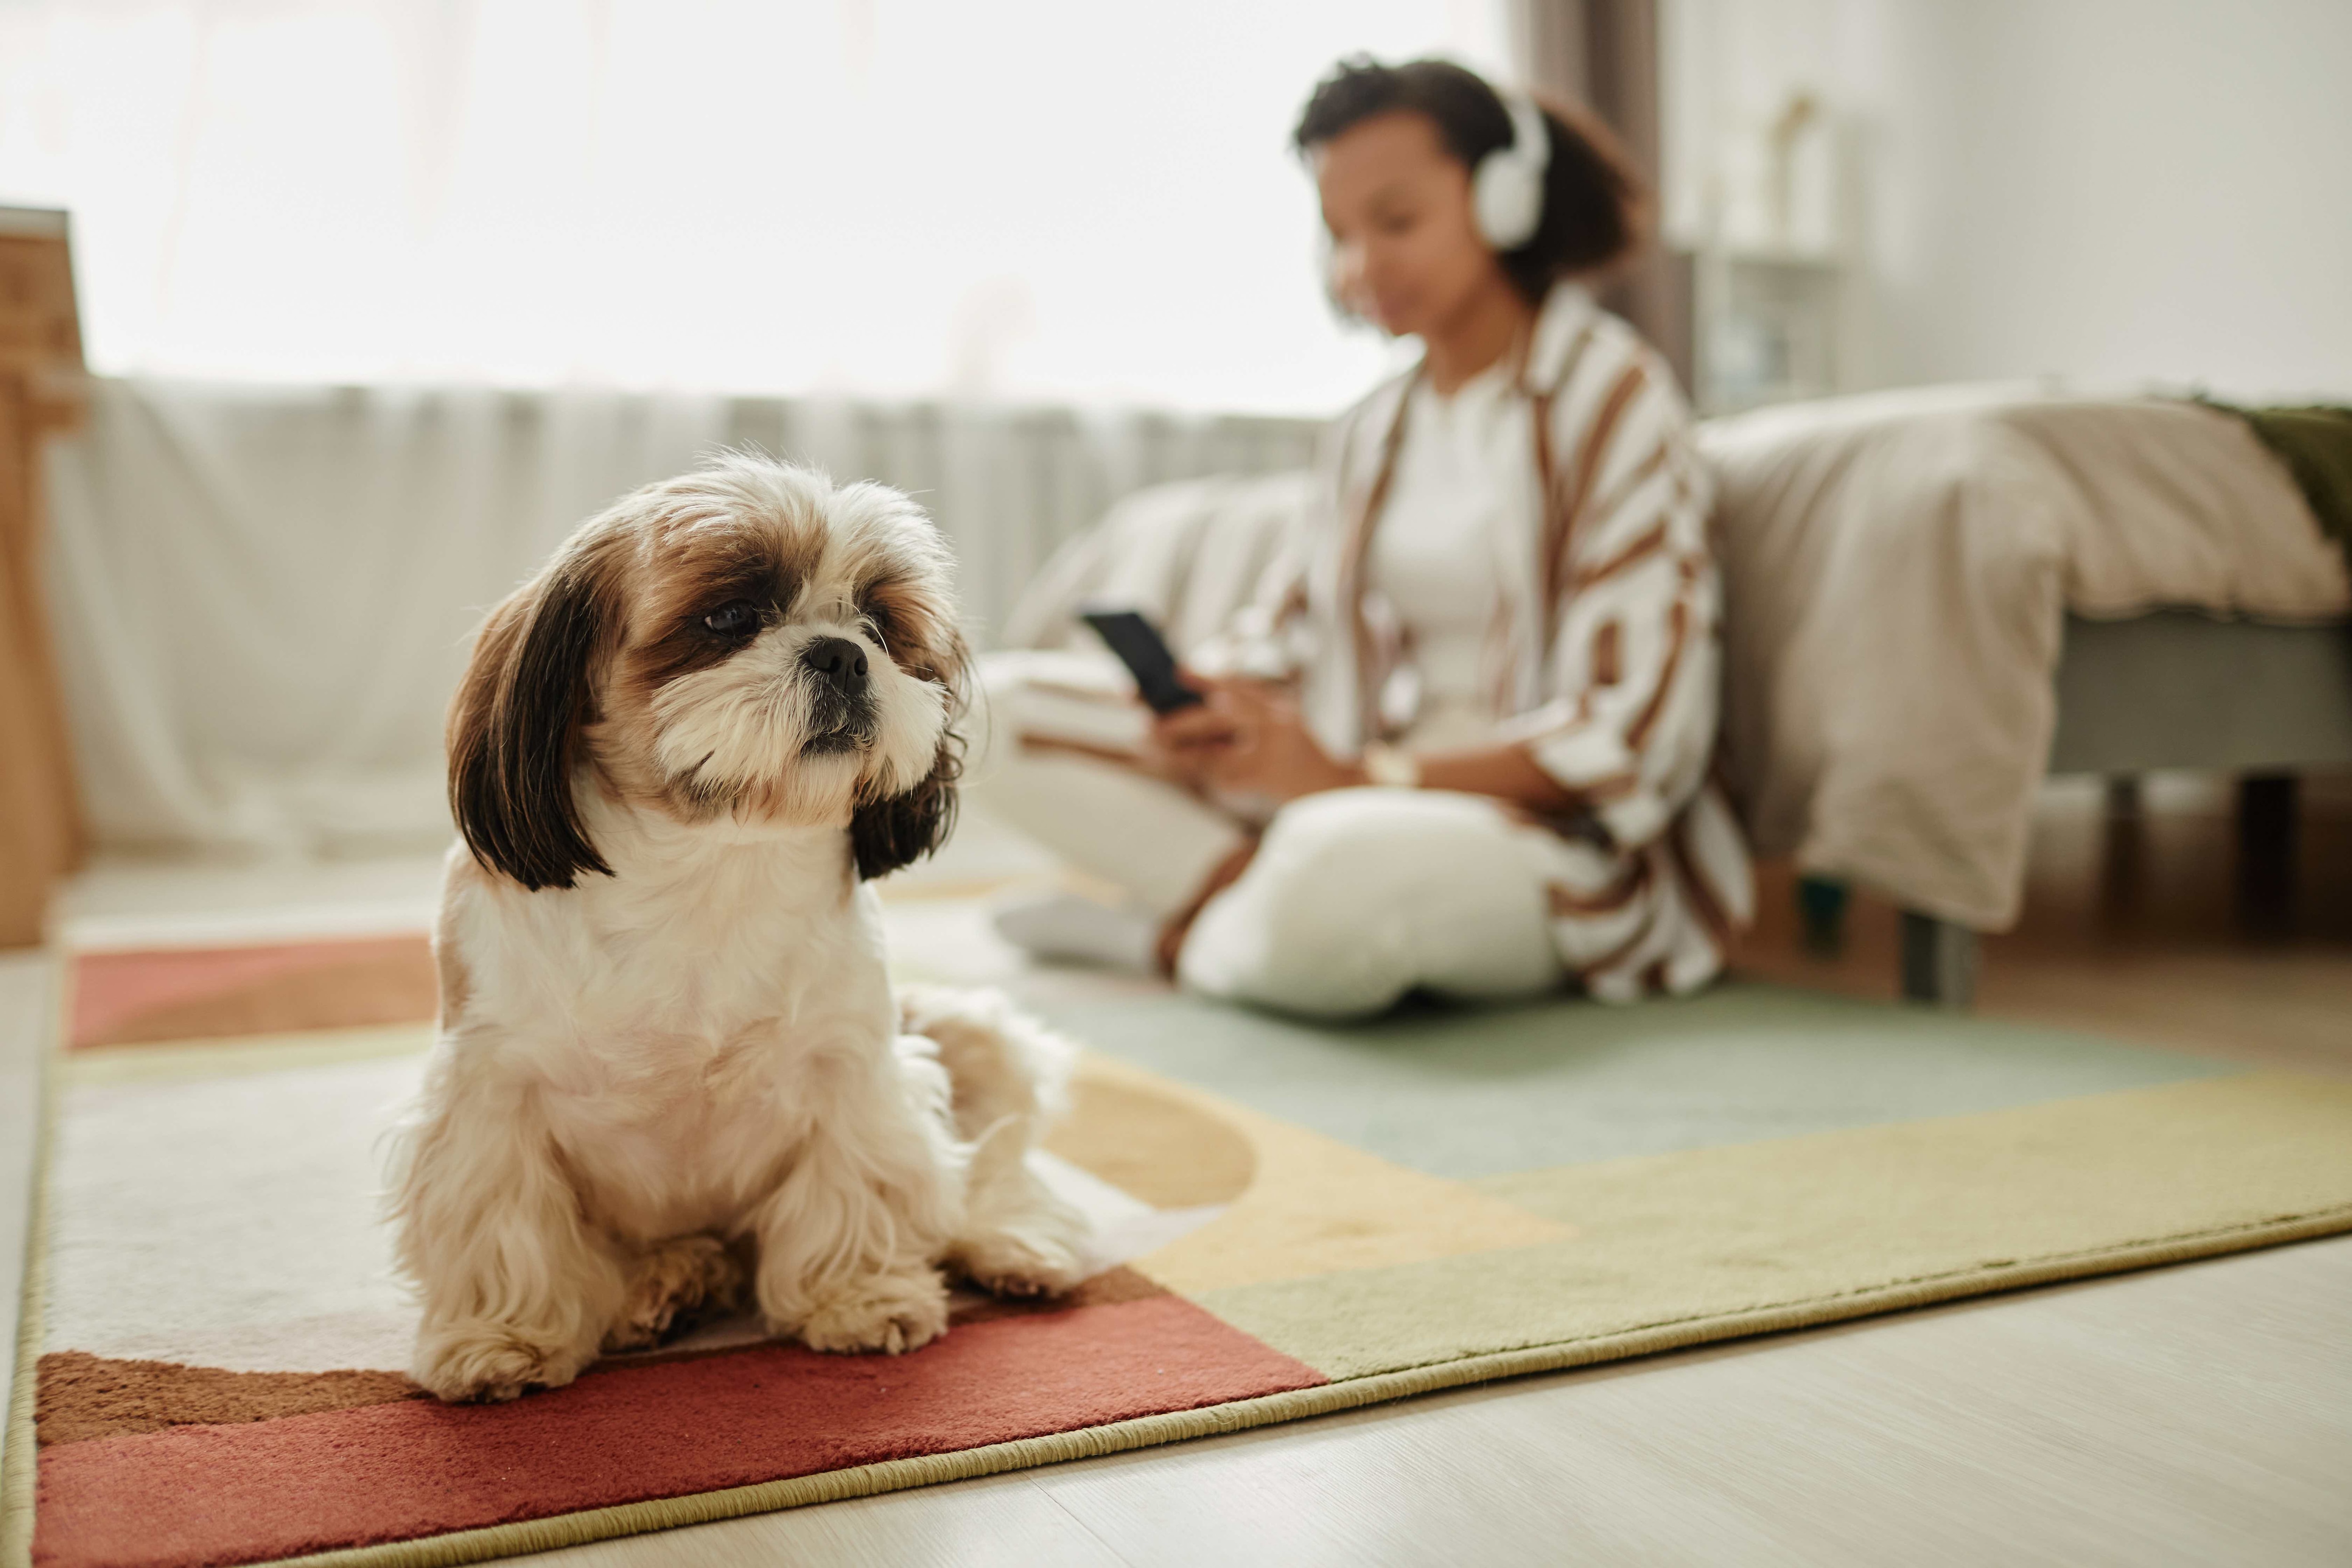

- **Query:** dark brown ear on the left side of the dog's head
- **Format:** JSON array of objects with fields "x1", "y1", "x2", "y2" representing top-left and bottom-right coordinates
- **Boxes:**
[{"x1": 449, "y1": 555, "x2": 612, "y2": 893}]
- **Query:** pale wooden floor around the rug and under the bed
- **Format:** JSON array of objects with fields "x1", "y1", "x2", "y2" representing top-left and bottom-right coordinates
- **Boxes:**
[{"x1": 0, "y1": 780, "x2": 2352, "y2": 1568}]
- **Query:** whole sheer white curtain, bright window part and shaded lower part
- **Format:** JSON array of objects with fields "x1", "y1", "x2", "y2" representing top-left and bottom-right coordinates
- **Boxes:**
[{"x1": 0, "y1": 0, "x2": 1505, "y2": 853}]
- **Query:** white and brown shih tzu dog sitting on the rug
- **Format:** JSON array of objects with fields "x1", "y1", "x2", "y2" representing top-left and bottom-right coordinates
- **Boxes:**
[{"x1": 390, "y1": 456, "x2": 1084, "y2": 1399}]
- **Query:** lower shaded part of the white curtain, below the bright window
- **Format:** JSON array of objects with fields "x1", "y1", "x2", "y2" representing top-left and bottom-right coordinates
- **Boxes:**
[{"x1": 49, "y1": 379, "x2": 1317, "y2": 853}]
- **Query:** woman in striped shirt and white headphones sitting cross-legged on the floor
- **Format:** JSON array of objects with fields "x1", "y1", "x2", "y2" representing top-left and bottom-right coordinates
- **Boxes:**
[{"x1": 976, "y1": 61, "x2": 1752, "y2": 1016}]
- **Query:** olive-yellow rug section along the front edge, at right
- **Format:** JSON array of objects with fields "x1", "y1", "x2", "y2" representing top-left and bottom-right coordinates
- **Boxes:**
[{"x1": 1200, "y1": 1075, "x2": 2352, "y2": 1377}]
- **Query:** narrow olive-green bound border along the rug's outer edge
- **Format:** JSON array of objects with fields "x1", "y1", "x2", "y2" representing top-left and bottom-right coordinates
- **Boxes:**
[{"x1": 14, "y1": 997, "x2": 2352, "y2": 1568}]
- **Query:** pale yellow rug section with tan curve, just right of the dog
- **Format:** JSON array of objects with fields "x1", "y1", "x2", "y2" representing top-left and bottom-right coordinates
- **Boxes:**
[{"x1": 1077, "y1": 1056, "x2": 1576, "y2": 1295}]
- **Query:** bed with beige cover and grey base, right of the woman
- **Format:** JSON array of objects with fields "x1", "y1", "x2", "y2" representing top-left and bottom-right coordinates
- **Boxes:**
[{"x1": 1700, "y1": 386, "x2": 2352, "y2": 1006}]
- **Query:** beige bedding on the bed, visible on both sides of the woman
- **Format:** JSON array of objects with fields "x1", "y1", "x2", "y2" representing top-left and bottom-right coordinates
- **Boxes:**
[{"x1": 1009, "y1": 388, "x2": 2352, "y2": 931}]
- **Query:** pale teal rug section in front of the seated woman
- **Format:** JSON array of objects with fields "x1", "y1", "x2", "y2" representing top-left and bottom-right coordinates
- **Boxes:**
[{"x1": 1033, "y1": 985, "x2": 2239, "y2": 1180}]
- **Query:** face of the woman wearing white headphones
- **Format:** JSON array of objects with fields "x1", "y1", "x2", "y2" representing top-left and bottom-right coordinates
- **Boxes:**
[{"x1": 1315, "y1": 111, "x2": 1510, "y2": 336}]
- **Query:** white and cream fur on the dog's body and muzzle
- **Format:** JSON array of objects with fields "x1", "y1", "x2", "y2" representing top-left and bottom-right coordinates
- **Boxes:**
[{"x1": 390, "y1": 465, "x2": 1082, "y2": 1399}]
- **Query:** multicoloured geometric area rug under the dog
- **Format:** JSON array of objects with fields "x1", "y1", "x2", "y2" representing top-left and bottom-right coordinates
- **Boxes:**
[{"x1": 5, "y1": 950, "x2": 2352, "y2": 1568}]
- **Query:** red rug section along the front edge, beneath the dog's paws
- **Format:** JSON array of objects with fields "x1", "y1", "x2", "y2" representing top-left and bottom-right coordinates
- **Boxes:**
[{"x1": 33, "y1": 1295, "x2": 1327, "y2": 1568}]
